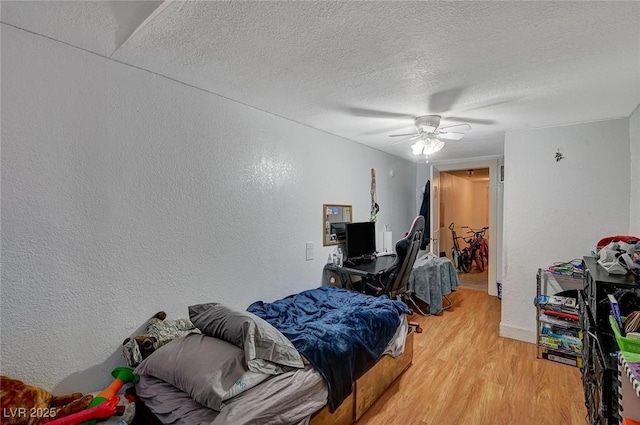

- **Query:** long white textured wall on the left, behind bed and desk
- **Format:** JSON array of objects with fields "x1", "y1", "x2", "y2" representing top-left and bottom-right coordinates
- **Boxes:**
[{"x1": 1, "y1": 26, "x2": 416, "y2": 393}]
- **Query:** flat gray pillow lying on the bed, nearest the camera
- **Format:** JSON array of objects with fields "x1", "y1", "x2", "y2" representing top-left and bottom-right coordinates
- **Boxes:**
[{"x1": 135, "y1": 334, "x2": 247, "y2": 411}]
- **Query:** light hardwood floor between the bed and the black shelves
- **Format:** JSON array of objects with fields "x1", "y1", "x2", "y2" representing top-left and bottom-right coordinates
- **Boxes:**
[{"x1": 356, "y1": 288, "x2": 587, "y2": 425}]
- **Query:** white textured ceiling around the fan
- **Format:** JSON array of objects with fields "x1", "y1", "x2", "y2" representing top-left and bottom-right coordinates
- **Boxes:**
[{"x1": 0, "y1": 1, "x2": 640, "y2": 161}]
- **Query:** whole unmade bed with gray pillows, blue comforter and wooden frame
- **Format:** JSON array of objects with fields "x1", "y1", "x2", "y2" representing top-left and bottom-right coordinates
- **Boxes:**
[{"x1": 134, "y1": 287, "x2": 413, "y2": 425}]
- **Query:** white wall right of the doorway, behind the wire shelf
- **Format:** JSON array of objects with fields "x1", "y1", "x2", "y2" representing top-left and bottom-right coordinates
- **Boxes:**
[{"x1": 500, "y1": 119, "x2": 630, "y2": 342}]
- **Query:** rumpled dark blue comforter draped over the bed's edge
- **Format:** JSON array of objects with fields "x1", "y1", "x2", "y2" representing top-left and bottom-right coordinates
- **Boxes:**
[{"x1": 247, "y1": 286, "x2": 409, "y2": 411}]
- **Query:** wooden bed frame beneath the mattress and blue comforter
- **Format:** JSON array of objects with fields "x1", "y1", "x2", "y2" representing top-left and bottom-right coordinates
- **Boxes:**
[{"x1": 132, "y1": 332, "x2": 414, "y2": 425}]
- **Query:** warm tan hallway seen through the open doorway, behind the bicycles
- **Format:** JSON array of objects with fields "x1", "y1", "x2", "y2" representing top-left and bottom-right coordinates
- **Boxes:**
[{"x1": 439, "y1": 167, "x2": 491, "y2": 292}]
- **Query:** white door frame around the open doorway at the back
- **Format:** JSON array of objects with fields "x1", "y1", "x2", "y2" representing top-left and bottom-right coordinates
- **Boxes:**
[{"x1": 429, "y1": 158, "x2": 502, "y2": 296}]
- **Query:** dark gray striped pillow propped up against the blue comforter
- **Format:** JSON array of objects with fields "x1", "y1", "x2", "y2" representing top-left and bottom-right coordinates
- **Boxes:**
[{"x1": 189, "y1": 303, "x2": 304, "y2": 375}]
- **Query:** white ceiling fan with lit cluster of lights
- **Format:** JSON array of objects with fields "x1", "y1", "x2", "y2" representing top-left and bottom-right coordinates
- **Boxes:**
[{"x1": 389, "y1": 115, "x2": 471, "y2": 159}]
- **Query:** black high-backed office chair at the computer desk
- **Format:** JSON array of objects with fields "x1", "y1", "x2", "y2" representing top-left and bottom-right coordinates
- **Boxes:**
[{"x1": 365, "y1": 215, "x2": 425, "y2": 311}]
